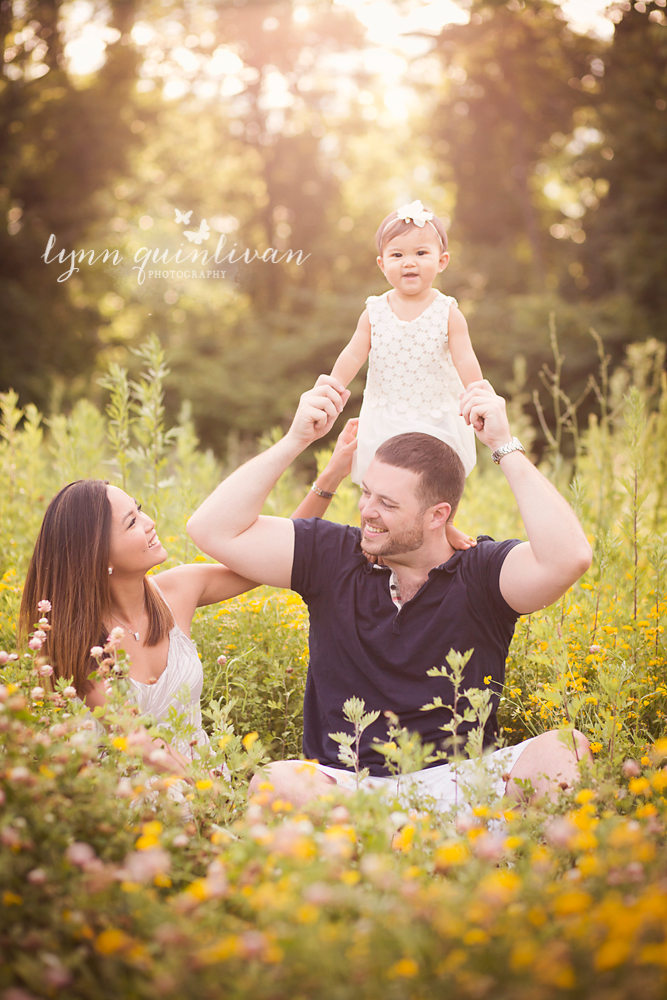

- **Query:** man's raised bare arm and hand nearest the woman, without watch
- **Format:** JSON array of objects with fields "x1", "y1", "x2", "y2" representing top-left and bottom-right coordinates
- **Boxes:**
[{"x1": 188, "y1": 375, "x2": 350, "y2": 587}]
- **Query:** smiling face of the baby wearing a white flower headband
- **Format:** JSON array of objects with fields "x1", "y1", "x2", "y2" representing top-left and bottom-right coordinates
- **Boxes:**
[{"x1": 377, "y1": 223, "x2": 449, "y2": 296}]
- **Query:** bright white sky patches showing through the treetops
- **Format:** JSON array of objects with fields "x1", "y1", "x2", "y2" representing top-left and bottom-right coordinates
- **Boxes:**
[{"x1": 63, "y1": 0, "x2": 613, "y2": 79}]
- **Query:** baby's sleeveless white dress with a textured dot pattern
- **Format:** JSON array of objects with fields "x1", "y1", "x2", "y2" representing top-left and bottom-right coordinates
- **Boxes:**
[{"x1": 352, "y1": 291, "x2": 475, "y2": 483}]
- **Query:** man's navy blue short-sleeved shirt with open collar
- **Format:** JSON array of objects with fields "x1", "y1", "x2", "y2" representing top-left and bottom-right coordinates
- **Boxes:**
[{"x1": 292, "y1": 518, "x2": 519, "y2": 776}]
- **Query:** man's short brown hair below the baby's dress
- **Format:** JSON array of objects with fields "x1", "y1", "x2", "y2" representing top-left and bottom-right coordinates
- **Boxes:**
[{"x1": 375, "y1": 431, "x2": 466, "y2": 514}]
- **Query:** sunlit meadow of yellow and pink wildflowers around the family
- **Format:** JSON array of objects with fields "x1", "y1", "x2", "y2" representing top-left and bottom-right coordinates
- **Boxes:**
[{"x1": 0, "y1": 342, "x2": 667, "y2": 1000}]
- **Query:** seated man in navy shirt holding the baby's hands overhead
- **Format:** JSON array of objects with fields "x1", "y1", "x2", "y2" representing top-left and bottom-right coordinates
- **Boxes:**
[{"x1": 188, "y1": 376, "x2": 591, "y2": 806}]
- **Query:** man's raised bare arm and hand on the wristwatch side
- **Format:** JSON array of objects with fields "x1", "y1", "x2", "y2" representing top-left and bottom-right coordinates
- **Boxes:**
[{"x1": 461, "y1": 380, "x2": 592, "y2": 614}]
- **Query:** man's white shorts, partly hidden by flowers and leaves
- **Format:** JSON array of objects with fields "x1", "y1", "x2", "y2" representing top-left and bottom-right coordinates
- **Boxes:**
[{"x1": 312, "y1": 739, "x2": 533, "y2": 811}]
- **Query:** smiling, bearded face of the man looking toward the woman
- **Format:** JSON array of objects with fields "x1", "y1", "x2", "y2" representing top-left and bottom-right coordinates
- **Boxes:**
[{"x1": 359, "y1": 459, "x2": 450, "y2": 557}]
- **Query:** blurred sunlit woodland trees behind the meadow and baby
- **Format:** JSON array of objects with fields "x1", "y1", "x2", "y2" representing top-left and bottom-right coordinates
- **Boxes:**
[{"x1": 0, "y1": 0, "x2": 667, "y2": 453}]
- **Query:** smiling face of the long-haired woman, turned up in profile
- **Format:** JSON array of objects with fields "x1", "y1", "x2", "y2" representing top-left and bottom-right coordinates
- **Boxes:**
[{"x1": 107, "y1": 486, "x2": 167, "y2": 577}]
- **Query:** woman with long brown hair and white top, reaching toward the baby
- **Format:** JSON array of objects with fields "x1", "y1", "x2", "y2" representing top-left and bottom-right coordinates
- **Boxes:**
[{"x1": 19, "y1": 420, "x2": 357, "y2": 776}]
